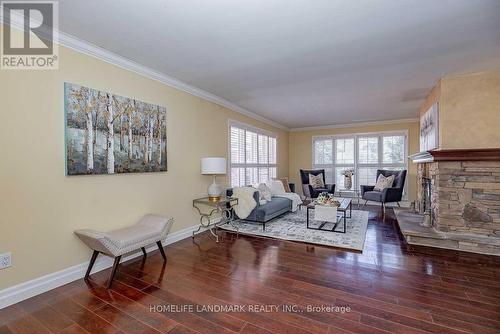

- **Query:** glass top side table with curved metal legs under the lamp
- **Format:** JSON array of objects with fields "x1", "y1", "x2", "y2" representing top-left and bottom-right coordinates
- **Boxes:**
[{"x1": 192, "y1": 197, "x2": 238, "y2": 242}]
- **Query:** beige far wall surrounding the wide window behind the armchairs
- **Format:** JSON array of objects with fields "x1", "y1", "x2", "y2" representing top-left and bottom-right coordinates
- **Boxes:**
[{"x1": 288, "y1": 122, "x2": 419, "y2": 201}]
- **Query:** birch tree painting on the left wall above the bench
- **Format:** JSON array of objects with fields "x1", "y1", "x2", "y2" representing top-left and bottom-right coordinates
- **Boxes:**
[{"x1": 64, "y1": 83, "x2": 167, "y2": 175}]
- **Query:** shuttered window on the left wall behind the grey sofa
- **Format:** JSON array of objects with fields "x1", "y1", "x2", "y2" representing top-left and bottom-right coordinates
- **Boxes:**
[{"x1": 229, "y1": 121, "x2": 277, "y2": 187}]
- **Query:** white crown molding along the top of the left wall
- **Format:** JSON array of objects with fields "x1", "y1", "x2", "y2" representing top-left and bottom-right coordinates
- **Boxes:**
[{"x1": 0, "y1": 15, "x2": 290, "y2": 131}]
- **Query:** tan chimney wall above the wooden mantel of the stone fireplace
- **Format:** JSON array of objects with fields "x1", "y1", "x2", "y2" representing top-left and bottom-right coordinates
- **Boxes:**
[{"x1": 439, "y1": 69, "x2": 500, "y2": 149}]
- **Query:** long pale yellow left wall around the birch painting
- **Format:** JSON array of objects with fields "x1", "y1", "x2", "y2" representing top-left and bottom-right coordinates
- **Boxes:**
[{"x1": 0, "y1": 42, "x2": 288, "y2": 289}]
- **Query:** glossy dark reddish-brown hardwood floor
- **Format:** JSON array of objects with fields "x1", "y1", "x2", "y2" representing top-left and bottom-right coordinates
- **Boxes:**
[{"x1": 0, "y1": 210, "x2": 500, "y2": 334}]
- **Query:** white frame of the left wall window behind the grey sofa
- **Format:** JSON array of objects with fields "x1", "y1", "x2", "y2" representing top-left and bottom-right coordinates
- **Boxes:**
[{"x1": 227, "y1": 119, "x2": 278, "y2": 187}]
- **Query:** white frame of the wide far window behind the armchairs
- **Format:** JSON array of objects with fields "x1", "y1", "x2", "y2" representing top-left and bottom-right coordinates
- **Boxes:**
[{"x1": 311, "y1": 130, "x2": 408, "y2": 199}]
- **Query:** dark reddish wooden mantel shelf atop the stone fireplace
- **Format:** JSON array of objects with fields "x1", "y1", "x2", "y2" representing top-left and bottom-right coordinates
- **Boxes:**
[{"x1": 408, "y1": 148, "x2": 500, "y2": 163}]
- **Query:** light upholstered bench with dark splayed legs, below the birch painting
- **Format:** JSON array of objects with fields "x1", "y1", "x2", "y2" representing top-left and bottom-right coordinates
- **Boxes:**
[{"x1": 75, "y1": 214, "x2": 174, "y2": 288}]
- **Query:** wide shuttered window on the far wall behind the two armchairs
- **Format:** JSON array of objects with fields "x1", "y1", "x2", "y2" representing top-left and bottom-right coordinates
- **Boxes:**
[{"x1": 313, "y1": 132, "x2": 407, "y2": 194}]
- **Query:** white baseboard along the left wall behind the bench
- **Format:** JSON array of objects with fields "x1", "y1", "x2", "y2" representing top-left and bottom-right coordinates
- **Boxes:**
[{"x1": 0, "y1": 225, "x2": 199, "y2": 309}]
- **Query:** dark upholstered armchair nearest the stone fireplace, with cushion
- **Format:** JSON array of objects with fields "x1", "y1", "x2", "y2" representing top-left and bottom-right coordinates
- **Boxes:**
[{"x1": 361, "y1": 169, "x2": 406, "y2": 212}]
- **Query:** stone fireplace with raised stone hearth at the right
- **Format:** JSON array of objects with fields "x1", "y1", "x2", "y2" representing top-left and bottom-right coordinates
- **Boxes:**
[{"x1": 396, "y1": 150, "x2": 500, "y2": 255}]
